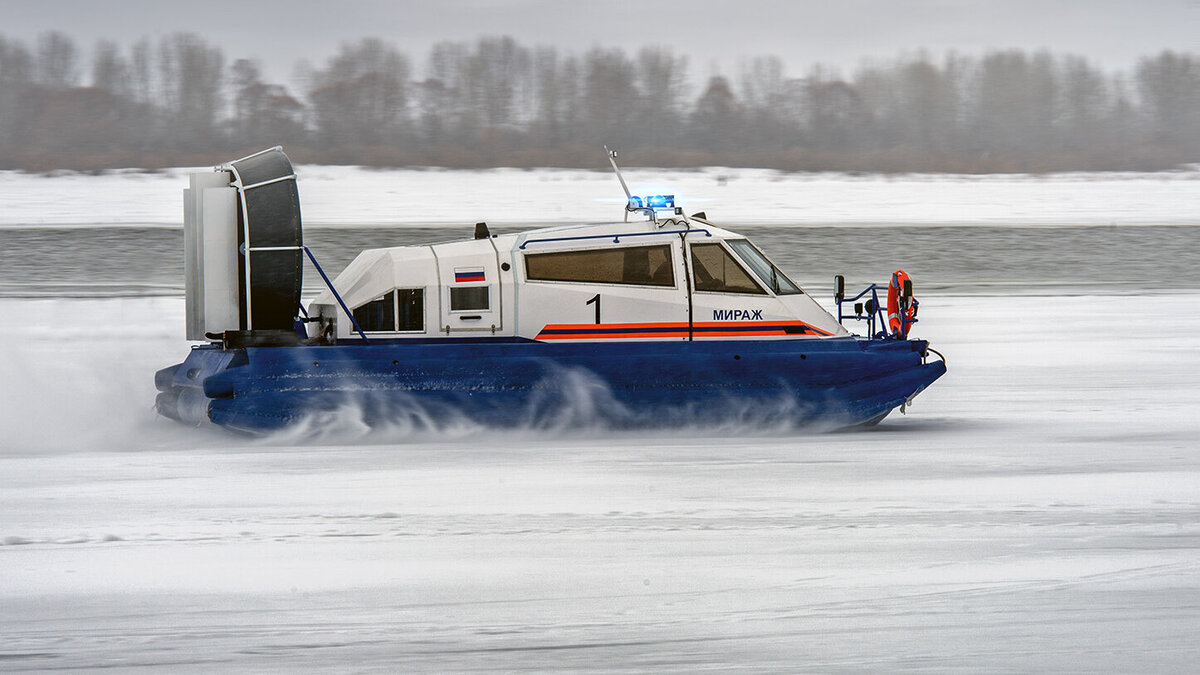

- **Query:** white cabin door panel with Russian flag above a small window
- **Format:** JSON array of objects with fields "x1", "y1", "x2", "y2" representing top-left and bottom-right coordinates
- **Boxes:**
[{"x1": 434, "y1": 239, "x2": 504, "y2": 335}]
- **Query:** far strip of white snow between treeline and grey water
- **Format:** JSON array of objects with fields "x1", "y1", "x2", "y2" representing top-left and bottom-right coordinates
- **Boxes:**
[{"x1": 7, "y1": 166, "x2": 1200, "y2": 227}]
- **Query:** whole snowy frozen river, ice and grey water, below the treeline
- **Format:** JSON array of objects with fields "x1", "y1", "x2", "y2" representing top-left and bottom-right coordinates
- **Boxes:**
[{"x1": 0, "y1": 167, "x2": 1200, "y2": 673}]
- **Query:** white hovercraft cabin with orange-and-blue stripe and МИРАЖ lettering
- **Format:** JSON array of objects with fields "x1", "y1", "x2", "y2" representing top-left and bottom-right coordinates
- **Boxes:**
[{"x1": 310, "y1": 216, "x2": 848, "y2": 341}]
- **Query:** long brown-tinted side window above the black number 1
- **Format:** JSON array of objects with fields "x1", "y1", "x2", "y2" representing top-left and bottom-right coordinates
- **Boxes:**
[{"x1": 524, "y1": 244, "x2": 674, "y2": 286}]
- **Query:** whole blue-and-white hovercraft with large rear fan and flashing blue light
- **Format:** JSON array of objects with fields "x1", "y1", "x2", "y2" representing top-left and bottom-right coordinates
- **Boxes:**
[{"x1": 155, "y1": 148, "x2": 946, "y2": 432}]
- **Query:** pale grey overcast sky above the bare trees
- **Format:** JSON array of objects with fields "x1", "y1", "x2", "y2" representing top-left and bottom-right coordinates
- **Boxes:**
[{"x1": 0, "y1": 0, "x2": 1200, "y2": 84}]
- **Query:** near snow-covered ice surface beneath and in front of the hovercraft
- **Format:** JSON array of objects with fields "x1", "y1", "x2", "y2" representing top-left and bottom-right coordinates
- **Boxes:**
[{"x1": 0, "y1": 294, "x2": 1200, "y2": 673}]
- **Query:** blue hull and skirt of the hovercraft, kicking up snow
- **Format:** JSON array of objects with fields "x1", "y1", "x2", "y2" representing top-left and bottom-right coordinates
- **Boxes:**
[{"x1": 156, "y1": 338, "x2": 946, "y2": 432}]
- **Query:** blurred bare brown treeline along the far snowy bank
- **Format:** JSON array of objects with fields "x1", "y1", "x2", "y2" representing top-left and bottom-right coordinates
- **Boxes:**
[{"x1": 0, "y1": 32, "x2": 1200, "y2": 173}]
